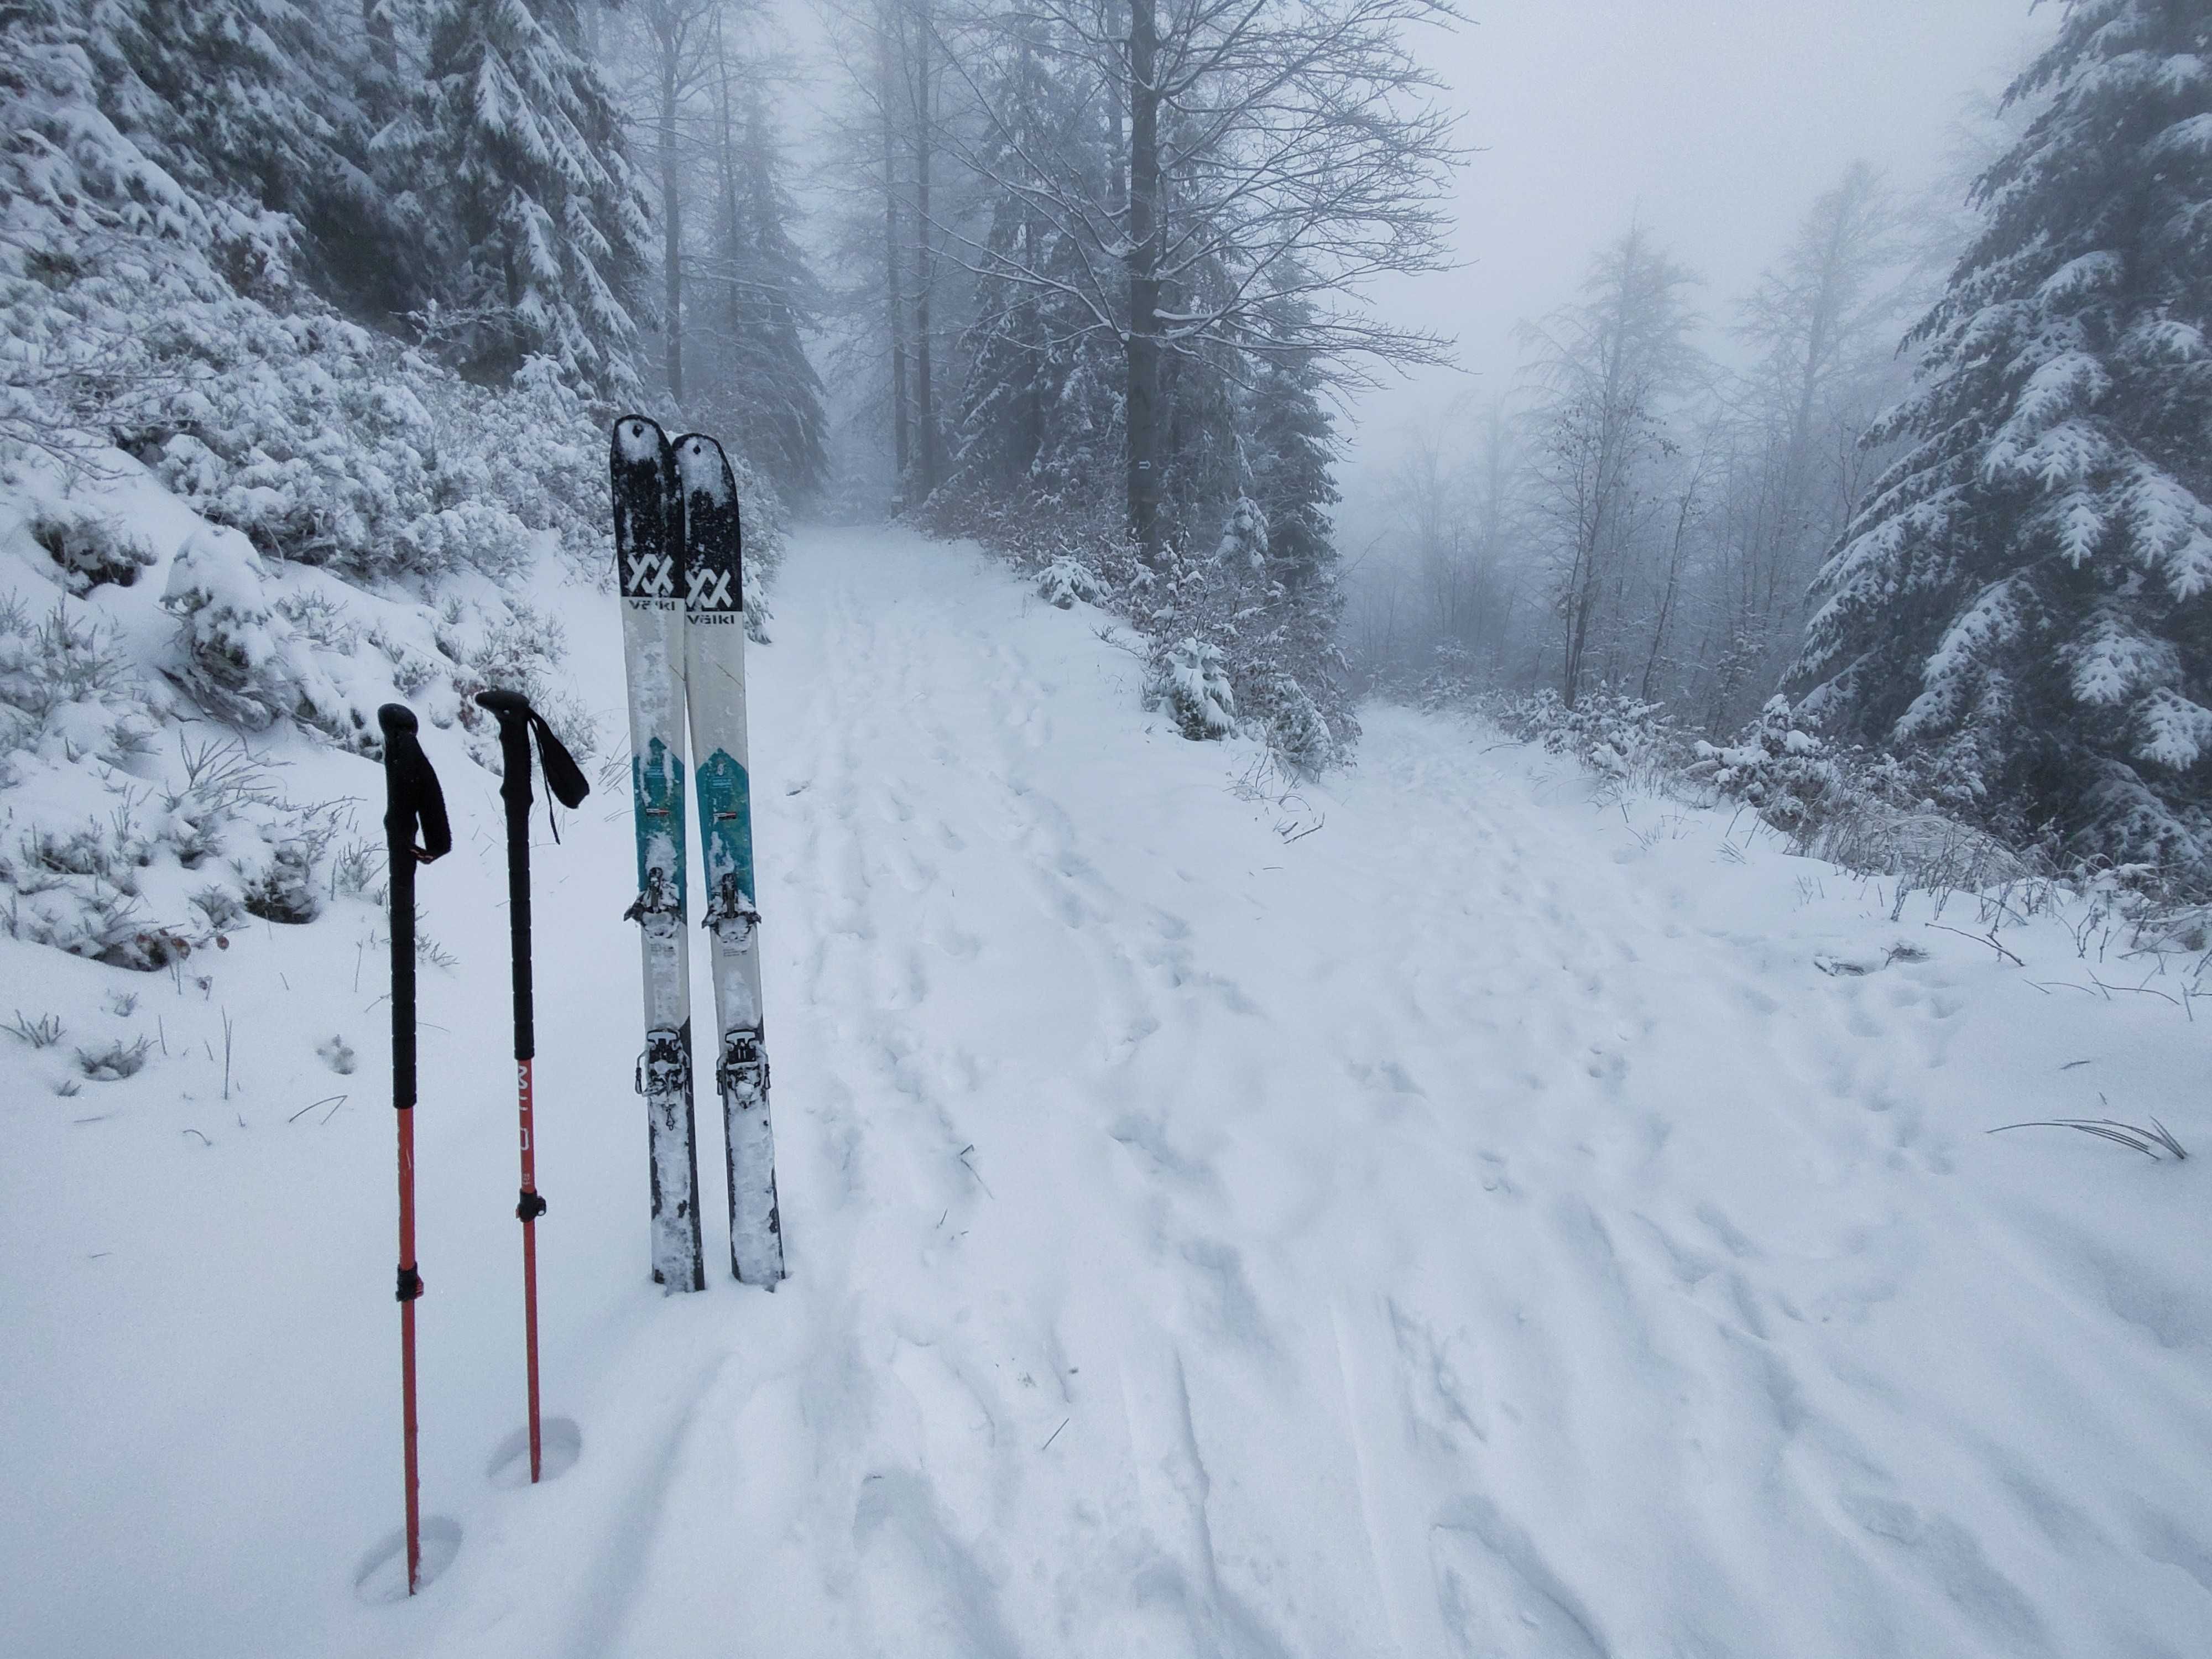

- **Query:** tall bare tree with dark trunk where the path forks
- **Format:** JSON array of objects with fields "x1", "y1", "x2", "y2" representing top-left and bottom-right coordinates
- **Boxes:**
[{"x1": 945, "y1": 0, "x2": 1460, "y2": 560}]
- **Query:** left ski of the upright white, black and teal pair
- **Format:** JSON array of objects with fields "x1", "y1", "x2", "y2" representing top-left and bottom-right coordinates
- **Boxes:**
[{"x1": 611, "y1": 416, "x2": 706, "y2": 1290}]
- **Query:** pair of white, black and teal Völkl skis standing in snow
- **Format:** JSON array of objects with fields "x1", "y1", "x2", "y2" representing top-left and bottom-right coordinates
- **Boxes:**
[{"x1": 611, "y1": 416, "x2": 783, "y2": 1290}]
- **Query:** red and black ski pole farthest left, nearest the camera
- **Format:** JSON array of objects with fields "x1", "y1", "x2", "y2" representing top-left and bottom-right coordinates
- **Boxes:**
[{"x1": 376, "y1": 703, "x2": 453, "y2": 1595}]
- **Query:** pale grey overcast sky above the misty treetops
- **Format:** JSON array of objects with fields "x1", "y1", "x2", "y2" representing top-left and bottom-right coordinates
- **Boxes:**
[{"x1": 1345, "y1": 0, "x2": 2059, "y2": 493}]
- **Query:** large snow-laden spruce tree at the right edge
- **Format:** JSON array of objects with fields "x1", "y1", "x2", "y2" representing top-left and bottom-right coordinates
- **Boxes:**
[{"x1": 1792, "y1": 0, "x2": 2212, "y2": 880}]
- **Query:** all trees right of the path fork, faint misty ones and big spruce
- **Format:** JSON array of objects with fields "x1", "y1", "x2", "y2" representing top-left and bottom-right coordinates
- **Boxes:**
[{"x1": 1347, "y1": 0, "x2": 2212, "y2": 891}]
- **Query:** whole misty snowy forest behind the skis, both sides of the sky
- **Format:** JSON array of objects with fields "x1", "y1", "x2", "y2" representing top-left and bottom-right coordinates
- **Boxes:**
[{"x1": 0, "y1": 0, "x2": 2212, "y2": 889}]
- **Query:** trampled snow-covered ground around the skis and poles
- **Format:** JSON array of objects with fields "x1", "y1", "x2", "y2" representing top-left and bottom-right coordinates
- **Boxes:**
[{"x1": 0, "y1": 531, "x2": 2212, "y2": 1659}]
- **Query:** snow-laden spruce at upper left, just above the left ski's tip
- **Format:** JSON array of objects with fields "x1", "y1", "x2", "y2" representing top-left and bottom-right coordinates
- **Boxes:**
[{"x1": 396, "y1": 0, "x2": 653, "y2": 396}]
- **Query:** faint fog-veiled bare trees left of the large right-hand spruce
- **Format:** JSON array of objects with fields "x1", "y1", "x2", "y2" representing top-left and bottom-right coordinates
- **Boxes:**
[{"x1": 1352, "y1": 164, "x2": 1933, "y2": 732}]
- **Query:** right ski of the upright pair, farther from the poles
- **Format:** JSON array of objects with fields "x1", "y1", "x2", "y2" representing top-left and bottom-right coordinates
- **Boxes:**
[{"x1": 675, "y1": 434, "x2": 783, "y2": 1290}]
